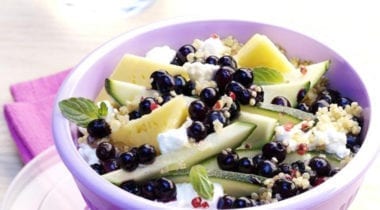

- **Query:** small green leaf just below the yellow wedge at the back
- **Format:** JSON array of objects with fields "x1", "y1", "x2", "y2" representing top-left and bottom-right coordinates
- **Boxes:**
[{"x1": 252, "y1": 67, "x2": 284, "y2": 85}]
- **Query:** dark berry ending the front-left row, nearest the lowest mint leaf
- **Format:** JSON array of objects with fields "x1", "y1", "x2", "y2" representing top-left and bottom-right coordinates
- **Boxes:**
[{"x1": 154, "y1": 178, "x2": 177, "y2": 202}]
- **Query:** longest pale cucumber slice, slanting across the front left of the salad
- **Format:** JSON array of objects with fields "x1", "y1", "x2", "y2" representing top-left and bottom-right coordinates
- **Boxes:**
[{"x1": 103, "y1": 122, "x2": 256, "y2": 184}]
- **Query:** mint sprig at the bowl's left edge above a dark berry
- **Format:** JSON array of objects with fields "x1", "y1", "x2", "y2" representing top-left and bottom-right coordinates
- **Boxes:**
[{"x1": 58, "y1": 97, "x2": 108, "y2": 127}]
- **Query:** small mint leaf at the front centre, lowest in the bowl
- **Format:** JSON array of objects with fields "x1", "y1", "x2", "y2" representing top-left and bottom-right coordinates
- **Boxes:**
[{"x1": 189, "y1": 165, "x2": 214, "y2": 199}]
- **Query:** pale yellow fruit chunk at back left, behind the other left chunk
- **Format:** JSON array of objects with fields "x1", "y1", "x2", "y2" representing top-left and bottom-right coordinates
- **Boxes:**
[{"x1": 96, "y1": 54, "x2": 189, "y2": 101}]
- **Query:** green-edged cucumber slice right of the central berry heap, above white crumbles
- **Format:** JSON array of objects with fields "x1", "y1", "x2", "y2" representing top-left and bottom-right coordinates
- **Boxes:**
[{"x1": 240, "y1": 104, "x2": 315, "y2": 125}]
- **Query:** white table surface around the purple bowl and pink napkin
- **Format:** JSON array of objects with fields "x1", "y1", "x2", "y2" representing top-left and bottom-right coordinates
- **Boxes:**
[{"x1": 0, "y1": 0, "x2": 380, "y2": 210}]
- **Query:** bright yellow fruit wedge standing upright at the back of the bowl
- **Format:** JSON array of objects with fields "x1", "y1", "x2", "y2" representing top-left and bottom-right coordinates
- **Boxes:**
[{"x1": 235, "y1": 34, "x2": 295, "y2": 74}]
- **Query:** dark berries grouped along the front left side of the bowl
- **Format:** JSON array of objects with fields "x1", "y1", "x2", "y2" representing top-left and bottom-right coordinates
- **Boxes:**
[{"x1": 87, "y1": 119, "x2": 177, "y2": 202}]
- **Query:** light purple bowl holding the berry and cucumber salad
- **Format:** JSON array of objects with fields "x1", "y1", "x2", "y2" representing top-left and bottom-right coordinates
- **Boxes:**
[{"x1": 53, "y1": 19, "x2": 379, "y2": 210}]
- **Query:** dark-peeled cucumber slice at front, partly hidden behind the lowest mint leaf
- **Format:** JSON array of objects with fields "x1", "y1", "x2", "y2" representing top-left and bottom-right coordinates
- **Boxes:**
[{"x1": 164, "y1": 169, "x2": 265, "y2": 197}]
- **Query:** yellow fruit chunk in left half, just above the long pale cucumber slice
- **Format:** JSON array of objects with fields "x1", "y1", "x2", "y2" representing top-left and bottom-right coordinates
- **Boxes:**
[{"x1": 111, "y1": 96, "x2": 188, "y2": 150}]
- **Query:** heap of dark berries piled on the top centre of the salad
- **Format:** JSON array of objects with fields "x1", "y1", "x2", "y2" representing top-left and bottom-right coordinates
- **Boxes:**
[{"x1": 150, "y1": 44, "x2": 264, "y2": 142}]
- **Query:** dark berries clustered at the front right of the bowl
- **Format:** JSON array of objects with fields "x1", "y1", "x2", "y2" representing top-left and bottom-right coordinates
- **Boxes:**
[{"x1": 217, "y1": 141, "x2": 337, "y2": 209}]
